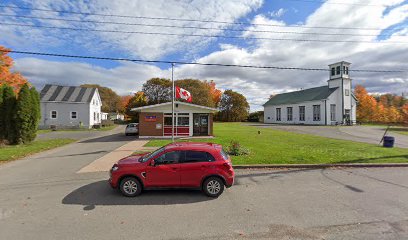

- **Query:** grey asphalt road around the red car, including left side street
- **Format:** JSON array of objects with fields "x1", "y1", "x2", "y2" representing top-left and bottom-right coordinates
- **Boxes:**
[{"x1": 0, "y1": 131, "x2": 408, "y2": 240}]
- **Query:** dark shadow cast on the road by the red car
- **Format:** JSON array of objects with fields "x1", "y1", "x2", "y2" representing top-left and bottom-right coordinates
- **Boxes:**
[{"x1": 62, "y1": 181, "x2": 213, "y2": 210}]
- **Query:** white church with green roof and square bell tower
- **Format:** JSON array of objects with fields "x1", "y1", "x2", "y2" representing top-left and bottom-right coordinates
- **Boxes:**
[{"x1": 264, "y1": 61, "x2": 357, "y2": 125}]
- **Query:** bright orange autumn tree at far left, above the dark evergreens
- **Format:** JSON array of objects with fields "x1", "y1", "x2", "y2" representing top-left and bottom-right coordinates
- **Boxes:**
[{"x1": 0, "y1": 46, "x2": 27, "y2": 93}]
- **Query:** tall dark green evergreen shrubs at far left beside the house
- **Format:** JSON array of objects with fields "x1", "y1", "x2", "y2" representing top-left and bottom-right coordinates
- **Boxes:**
[{"x1": 0, "y1": 82, "x2": 41, "y2": 144}]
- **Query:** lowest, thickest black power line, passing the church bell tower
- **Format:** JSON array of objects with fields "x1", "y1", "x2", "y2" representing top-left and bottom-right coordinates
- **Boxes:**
[{"x1": 0, "y1": 50, "x2": 408, "y2": 73}]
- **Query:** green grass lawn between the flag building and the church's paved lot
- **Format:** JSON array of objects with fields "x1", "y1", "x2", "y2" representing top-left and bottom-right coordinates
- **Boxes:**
[{"x1": 145, "y1": 123, "x2": 408, "y2": 164}]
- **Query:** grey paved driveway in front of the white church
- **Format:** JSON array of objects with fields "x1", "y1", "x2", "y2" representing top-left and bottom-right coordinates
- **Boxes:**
[{"x1": 252, "y1": 123, "x2": 408, "y2": 148}]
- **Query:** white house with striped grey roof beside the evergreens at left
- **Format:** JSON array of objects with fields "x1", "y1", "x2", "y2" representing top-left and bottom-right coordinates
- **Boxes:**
[{"x1": 39, "y1": 84, "x2": 102, "y2": 128}]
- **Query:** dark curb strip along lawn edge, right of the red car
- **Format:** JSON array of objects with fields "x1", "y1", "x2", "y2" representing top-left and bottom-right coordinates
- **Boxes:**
[{"x1": 233, "y1": 163, "x2": 408, "y2": 169}]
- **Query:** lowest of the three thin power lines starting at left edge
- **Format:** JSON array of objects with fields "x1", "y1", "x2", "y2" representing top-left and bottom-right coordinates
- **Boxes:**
[{"x1": 0, "y1": 22, "x2": 408, "y2": 44}]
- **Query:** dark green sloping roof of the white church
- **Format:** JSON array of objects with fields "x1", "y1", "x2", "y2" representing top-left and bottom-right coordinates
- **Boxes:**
[{"x1": 264, "y1": 86, "x2": 337, "y2": 106}]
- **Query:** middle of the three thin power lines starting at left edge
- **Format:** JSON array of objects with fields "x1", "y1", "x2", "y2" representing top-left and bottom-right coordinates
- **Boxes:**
[{"x1": 0, "y1": 14, "x2": 398, "y2": 37}]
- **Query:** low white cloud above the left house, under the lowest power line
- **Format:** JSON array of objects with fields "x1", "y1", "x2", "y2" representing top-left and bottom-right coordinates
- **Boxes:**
[{"x1": 14, "y1": 58, "x2": 169, "y2": 95}]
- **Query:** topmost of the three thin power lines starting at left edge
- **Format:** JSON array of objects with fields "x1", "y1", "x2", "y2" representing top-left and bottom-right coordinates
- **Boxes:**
[{"x1": 0, "y1": 5, "x2": 388, "y2": 30}]
